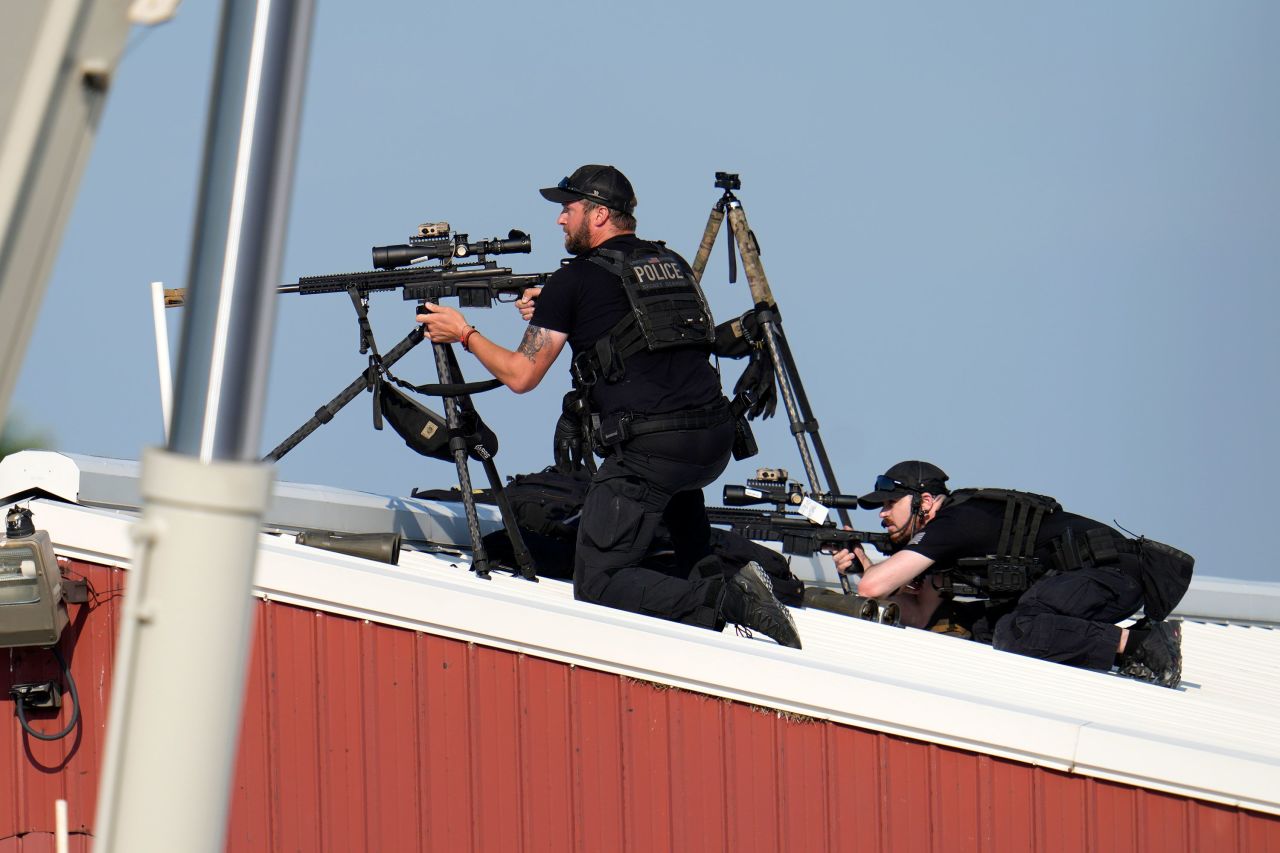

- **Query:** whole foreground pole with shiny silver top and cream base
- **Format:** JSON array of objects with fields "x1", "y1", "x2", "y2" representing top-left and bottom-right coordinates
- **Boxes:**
[{"x1": 95, "y1": 0, "x2": 314, "y2": 853}]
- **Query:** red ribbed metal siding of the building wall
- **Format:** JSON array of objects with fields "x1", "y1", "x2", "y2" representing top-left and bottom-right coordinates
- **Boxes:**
[{"x1": 0, "y1": 555, "x2": 1280, "y2": 853}]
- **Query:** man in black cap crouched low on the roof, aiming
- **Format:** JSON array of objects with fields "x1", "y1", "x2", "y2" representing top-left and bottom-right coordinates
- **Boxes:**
[{"x1": 836, "y1": 461, "x2": 1194, "y2": 688}]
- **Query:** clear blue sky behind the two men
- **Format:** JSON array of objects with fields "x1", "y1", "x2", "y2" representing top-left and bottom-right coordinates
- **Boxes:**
[{"x1": 13, "y1": 0, "x2": 1280, "y2": 579}]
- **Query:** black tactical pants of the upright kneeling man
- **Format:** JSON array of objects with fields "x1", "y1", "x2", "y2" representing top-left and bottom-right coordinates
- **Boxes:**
[{"x1": 573, "y1": 419, "x2": 733, "y2": 630}]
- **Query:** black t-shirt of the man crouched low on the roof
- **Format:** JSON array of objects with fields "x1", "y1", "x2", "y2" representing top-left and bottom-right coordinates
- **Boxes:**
[{"x1": 902, "y1": 497, "x2": 1107, "y2": 569}]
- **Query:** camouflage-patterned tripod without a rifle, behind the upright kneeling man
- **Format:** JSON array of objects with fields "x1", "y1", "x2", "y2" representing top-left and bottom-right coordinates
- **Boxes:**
[{"x1": 694, "y1": 172, "x2": 851, "y2": 593}]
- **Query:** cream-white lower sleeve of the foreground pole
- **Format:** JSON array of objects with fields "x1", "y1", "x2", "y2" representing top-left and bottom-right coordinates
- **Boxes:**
[{"x1": 93, "y1": 448, "x2": 273, "y2": 853}]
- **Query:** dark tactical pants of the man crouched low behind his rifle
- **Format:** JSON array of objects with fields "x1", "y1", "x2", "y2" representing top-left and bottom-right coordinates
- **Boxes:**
[{"x1": 992, "y1": 555, "x2": 1142, "y2": 672}]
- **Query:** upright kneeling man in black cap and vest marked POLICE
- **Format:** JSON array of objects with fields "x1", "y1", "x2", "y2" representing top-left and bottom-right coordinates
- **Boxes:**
[{"x1": 417, "y1": 165, "x2": 800, "y2": 648}]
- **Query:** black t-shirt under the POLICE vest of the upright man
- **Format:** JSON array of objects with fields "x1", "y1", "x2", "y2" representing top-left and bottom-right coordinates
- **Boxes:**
[{"x1": 530, "y1": 234, "x2": 722, "y2": 415}]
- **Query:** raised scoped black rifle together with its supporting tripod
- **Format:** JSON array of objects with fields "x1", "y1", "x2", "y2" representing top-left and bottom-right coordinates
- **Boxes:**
[{"x1": 264, "y1": 223, "x2": 549, "y2": 580}]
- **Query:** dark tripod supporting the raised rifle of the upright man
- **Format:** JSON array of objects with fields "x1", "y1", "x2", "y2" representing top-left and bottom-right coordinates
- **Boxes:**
[{"x1": 262, "y1": 287, "x2": 538, "y2": 581}]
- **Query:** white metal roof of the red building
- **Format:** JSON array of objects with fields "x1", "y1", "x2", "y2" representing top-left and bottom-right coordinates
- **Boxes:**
[{"x1": 30, "y1": 502, "x2": 1280, "y2": 815}]
